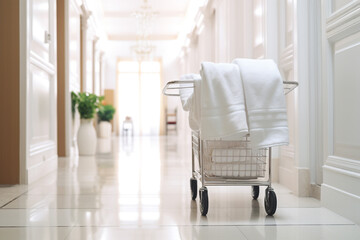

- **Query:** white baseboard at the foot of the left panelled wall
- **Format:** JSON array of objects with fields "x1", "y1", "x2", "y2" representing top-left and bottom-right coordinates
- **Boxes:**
[{"x1": 26, "y1": 155, "x2": 58, "y2": 184}]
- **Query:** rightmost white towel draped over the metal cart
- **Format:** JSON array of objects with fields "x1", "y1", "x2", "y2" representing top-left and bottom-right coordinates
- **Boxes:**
[{"x1": 233, "y1": 59, "x2": 289, "y2": 148}]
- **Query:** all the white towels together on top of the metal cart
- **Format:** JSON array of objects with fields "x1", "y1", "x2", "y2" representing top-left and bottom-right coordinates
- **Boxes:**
[{"x1": 180, "y1": 59, "x2": 289, "y2": 149}]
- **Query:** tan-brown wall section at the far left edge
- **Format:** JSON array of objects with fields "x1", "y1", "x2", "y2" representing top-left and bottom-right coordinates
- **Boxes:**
[{"x1": 0, "y1": 0, "x2": 20, "y2": 184}]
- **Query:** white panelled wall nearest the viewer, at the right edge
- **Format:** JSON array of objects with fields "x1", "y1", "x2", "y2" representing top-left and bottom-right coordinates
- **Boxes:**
[{"x1": 320, "y1": 0, "x2": 360, "y2": 224}]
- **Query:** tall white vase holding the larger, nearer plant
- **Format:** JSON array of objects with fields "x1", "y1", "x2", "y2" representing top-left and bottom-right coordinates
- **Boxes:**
[{"x1": 77, "y1": 119, "x2": 96, "y2": 155}]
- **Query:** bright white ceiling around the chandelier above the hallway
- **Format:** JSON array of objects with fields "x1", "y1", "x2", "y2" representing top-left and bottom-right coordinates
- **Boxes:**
[{"x1": 102, "y1": 0, "x2": 189, "y2": 41}]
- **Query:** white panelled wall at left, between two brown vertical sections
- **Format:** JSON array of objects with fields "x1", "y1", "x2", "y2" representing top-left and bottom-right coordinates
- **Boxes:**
[{"x1": 20, "y1": 0, "x2": 57, "y2": 184}]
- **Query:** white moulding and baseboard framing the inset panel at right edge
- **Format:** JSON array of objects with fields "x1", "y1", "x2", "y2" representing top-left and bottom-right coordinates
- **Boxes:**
[{"x1": 321, "y1": 0, "x2": 360, "y2": 227}]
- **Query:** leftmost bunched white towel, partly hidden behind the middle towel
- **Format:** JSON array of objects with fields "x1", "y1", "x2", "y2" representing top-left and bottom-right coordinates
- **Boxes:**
[{"x1": 179, "y1": 73, "x2": 201, "y2": 131}]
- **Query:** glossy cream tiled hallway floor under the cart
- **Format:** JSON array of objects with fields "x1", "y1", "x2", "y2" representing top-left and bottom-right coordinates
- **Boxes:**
[{"x1": 0, "y1": 136, "x2": 360, "y2": 240}]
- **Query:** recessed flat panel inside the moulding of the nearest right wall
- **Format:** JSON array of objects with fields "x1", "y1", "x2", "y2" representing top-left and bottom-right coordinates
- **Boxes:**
[{"x1": 333, "y1": 33, "x2": 360, "y2": 161}]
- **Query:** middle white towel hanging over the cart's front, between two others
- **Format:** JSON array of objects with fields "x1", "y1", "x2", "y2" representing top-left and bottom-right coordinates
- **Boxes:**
[{"x1": 200, "y1": 62, "x2": 248, "y2": 140}]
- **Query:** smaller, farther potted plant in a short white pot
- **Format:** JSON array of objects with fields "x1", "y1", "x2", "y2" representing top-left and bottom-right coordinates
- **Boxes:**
[{"x1": 98, "y1": 104, "x2": 115, "y2": 138}]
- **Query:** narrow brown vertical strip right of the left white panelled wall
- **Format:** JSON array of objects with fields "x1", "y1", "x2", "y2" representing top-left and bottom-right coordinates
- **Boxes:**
[{"x1": 56, "y1": 0, "x2": 66, "y2": 157}]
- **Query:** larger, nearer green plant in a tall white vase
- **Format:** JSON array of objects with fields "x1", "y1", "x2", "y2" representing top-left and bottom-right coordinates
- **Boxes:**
[{"x1": 76, "y1": 93, "x2": 103, "y2": 155}]
